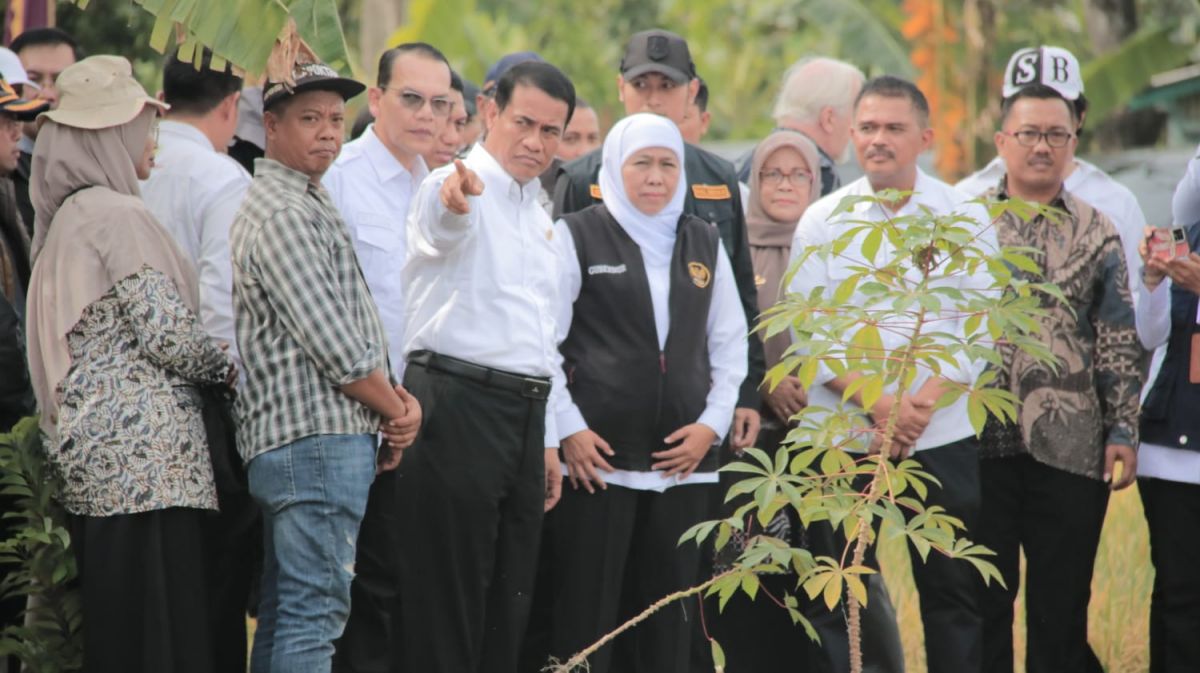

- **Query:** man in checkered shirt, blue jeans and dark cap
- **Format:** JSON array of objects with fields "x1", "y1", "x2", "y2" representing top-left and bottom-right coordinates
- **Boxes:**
[{"x1": 230, "y1": 62, "x2": 420, "y2": 673}]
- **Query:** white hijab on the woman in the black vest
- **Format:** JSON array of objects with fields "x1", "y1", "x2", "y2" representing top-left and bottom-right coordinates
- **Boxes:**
[{"x1": 600, "y1": 113, "x2": 688, "y2": 266}]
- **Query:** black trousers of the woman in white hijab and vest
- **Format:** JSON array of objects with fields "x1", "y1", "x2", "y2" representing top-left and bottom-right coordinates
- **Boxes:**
[{"x1": 550, "y1": 485, "x2": 713, "y2": 673}]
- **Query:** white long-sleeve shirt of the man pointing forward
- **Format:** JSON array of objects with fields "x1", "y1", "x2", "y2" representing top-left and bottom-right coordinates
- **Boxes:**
[{"x1": 404, "y1": 145, "x2": 562, "y2": 447}]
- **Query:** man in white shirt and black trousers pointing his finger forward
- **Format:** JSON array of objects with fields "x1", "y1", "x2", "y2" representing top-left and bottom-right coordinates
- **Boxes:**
[{"x1": 398, "y1": 62, "x2": 575, "y2": 673}]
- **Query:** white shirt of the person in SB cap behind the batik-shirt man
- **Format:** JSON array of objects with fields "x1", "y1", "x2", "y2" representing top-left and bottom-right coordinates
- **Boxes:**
[{"x1": 955, "y1": 157, "x2": 1150, "y2": 314}]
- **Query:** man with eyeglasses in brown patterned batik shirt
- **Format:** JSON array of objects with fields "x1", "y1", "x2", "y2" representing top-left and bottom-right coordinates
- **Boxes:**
[{"x1": 972, "y1": 84, "x2": 1142, "y2": 673}]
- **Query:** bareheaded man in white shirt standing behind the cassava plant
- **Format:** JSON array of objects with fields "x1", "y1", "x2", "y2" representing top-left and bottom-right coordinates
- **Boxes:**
[{"x1": 788, "y1": 77, "x2": 996, "y2": 673}]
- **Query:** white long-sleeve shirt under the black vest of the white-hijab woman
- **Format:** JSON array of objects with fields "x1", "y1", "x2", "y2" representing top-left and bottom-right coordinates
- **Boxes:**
[{"x1": 554, "y1": 220, "x2": 749, "y2": 492}]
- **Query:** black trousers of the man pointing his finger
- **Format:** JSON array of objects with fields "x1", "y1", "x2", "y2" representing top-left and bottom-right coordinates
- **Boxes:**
[{"x1": 397, "y1": 365, "x2": 546, "y2": 673}]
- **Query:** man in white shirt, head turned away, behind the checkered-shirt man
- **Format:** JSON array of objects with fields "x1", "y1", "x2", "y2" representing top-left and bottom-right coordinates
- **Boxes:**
[{"x1": 142, "y1": 48, "x2": 260, "y2": 671}]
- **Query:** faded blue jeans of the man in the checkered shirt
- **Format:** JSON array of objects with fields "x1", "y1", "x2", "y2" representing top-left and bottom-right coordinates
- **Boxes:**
[{"x1": 247, "y1": 434, "x2": 376, "y2": 673}]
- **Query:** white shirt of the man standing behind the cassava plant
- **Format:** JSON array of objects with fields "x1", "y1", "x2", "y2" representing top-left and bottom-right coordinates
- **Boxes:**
[{"x1": 787, "y1": 169, "x2": 998, "y2": 451}]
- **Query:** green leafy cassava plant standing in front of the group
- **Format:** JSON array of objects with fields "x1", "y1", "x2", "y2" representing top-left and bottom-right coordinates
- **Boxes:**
[{"x1": 550, "y1": 191, "x2": 1062, "y2": 673}]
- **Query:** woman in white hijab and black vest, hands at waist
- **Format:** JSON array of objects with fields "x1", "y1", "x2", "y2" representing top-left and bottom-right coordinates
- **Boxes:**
[{"x1": 548, "y1": 114, "x2": 748, "y2": 673}]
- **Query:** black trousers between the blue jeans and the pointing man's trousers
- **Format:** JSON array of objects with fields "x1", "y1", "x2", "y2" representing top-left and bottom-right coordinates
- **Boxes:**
[{"x1": 334, "y1": 470, "x2": 402, "y2": 673}]
